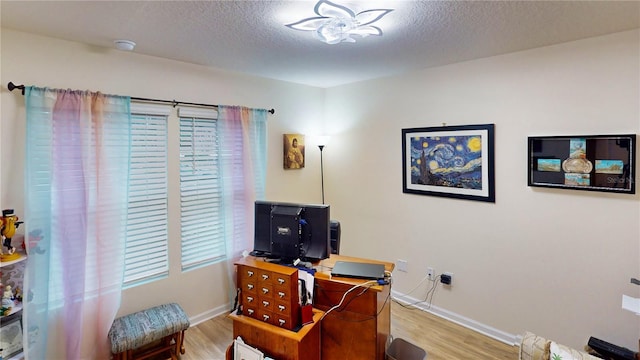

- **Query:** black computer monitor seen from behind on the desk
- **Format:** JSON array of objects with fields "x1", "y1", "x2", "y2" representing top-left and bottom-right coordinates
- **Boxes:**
[{"x1": 252, "y1": 200, "x2": 331, "y2": 262}]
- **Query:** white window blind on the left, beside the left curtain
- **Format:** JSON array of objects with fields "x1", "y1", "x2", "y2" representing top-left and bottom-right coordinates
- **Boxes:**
[{"x1": 124, "y1": 104, "x2": 170, "y2": 286}]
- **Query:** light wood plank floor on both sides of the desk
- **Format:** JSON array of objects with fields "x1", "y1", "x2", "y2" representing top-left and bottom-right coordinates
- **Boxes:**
[{"x1": 176, "y1": 302, "x2": 518, "y2": 360}]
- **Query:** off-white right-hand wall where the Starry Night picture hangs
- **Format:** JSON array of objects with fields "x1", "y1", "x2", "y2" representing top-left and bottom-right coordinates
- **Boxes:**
[{"x1": 324, "y1": 31, "x2": 640, "y2": 349}]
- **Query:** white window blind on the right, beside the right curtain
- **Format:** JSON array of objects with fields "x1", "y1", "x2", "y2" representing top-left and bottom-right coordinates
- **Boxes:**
[{"x1": 178, "y1": 108, "x2": 226, "y2": 270}]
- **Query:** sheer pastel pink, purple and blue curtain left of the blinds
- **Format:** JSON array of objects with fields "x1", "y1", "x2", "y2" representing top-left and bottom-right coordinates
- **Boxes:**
[{"x1": 24, "y1": 87, "x2": 130, "y2": 359}]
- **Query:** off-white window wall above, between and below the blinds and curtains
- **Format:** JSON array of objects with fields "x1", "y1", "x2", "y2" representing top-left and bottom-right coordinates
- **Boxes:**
[{"x1": 0, "y1": 29, "x2": 324, "y2": 321}]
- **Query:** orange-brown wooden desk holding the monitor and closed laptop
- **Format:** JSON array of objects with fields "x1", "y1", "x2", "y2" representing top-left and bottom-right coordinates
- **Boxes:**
[{"x1": 227, "y1": 254, "x2": 394, "y2": 360}]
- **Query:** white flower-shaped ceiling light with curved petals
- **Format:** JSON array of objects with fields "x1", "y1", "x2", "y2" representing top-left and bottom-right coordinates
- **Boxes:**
[{"x1": 285, "y1": 0, "x2": 393, "y2": 44}]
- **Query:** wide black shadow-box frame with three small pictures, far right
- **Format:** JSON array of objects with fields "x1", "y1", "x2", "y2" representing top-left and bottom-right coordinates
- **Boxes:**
[{"x1": 527, "y1": 134, "x2": 636, "y2": 194}]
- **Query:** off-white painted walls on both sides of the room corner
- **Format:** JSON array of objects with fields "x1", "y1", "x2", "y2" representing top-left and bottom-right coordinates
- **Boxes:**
[{"x1": 0, "y1": 29, "x2": 640, "y2": 354}]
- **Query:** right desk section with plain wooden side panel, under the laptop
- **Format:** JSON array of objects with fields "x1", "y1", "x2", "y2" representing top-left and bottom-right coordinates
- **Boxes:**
[{"x1": 313, "y1": 254, "x2": 394, "y2": 360}]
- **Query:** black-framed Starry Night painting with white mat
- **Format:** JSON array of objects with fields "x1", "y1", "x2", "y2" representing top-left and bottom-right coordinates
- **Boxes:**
[{"x1": 402, "y1": 124, "x2": 495, "y2": 202}]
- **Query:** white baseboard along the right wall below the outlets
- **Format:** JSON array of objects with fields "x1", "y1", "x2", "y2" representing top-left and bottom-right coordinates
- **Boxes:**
[{"x1": 391, "y1": 290, "x2": 522, "y2": 346}]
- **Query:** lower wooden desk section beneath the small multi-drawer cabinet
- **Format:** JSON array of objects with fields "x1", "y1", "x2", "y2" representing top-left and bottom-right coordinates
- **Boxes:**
[{"x1": 227, "y1": 309, "x2": 324, "y2": 360}]
